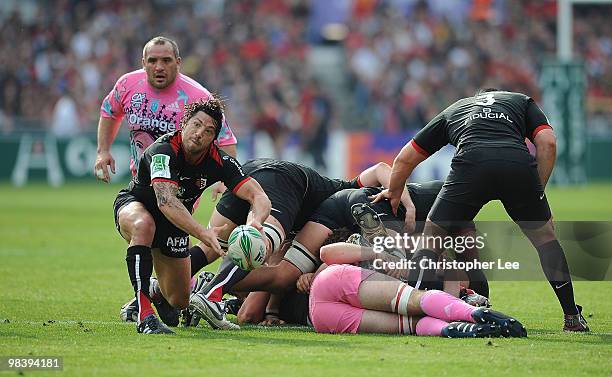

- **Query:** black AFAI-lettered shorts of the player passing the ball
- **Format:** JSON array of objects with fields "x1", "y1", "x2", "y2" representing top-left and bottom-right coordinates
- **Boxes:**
[{"x1": 113, "y1": 189, "x2": 189, "y2": 258}]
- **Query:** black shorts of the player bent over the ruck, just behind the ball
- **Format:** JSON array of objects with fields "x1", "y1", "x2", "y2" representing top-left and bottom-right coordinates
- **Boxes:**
[{"x1": 216, "y1": 169, "x2": 306, "y2": 235}]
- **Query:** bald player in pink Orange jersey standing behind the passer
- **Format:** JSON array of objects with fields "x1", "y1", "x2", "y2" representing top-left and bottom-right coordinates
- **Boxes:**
[{"x1": 94, "y1": 37, "x2": 237, "y2": 182}]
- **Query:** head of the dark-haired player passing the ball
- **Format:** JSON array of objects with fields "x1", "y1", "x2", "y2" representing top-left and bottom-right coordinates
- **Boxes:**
[{"x1": 181, "y1": 96, "x2": 223, "y2": 154}]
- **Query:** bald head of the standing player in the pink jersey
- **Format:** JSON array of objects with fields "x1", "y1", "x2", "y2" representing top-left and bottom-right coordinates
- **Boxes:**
[{"x1": 142, "y1": 37, "x2": 181, "y2": 89}]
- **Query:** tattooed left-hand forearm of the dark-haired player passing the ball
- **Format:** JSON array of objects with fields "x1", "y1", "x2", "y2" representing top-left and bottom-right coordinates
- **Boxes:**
[{"x1": 153, "y1": 182, "x2": 223, "y2": 255}]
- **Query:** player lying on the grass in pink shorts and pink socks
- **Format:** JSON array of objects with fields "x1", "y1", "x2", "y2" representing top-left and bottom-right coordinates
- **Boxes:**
[{"x1": 309, "y1": 262, "x2": 527, "y2": 338}]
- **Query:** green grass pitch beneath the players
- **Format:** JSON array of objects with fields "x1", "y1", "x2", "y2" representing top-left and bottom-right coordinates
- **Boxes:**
[{"x1": 0, "y1": 184, "x2": 612, "y2": 377}]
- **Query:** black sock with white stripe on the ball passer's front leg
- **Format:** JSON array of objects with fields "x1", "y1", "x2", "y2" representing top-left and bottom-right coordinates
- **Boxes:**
[{"x1": 125, "y1": 245, "x2": 153, "y2": 320}]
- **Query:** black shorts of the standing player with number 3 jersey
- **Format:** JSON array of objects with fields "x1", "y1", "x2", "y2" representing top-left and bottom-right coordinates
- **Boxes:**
[{"x1": 429, "y1": 148, "x2": 551, "y2": 229}]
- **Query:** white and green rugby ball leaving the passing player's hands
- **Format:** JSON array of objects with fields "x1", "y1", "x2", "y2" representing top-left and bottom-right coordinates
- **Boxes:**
[{"x1": 227, "y1": 225, "x2": 266, "y2": 271}]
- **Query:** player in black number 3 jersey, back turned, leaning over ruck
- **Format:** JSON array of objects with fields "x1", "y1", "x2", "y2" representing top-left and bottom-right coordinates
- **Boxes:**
[{"x1": 375, "y1": 89, "x2": 589, "y2": 331}]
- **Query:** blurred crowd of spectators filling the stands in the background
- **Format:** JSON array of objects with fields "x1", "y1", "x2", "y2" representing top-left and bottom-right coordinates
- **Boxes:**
[{"x1": 0, "y1": 0, "x2": 612, "y2": 143}]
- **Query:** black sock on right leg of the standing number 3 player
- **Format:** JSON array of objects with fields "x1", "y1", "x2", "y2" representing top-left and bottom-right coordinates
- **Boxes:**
[{"x1": 536, "y1": 240, "x2": 578, "y2": 314}]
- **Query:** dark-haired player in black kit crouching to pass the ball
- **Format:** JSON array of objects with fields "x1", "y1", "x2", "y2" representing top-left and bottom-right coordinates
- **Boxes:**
[{"x1": 114, "y1": 97, "x2": 270, "y2": 334}]
